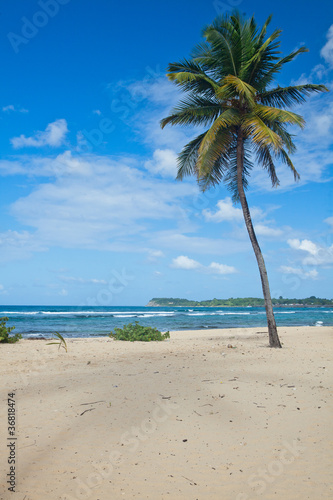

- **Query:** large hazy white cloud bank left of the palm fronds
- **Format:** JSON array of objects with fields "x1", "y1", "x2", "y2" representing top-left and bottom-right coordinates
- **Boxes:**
[{"x1": 0, "y1": 152, "x2": 193, "y2": 251}]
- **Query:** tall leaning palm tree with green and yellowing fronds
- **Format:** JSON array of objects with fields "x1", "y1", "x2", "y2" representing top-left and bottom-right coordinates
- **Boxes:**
[{"x1": 161, "y1": 11, "x2": 327, "y2": 347}]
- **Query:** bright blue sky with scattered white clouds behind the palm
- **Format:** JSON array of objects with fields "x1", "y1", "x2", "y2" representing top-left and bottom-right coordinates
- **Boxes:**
[{"x1": 0, "y1": 0, "x2": 333, "y2": 306}]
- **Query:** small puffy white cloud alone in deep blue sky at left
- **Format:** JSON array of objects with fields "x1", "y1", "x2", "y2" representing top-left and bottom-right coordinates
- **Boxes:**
[{"x1": 10, "y1": 119, "x2": 68, "y2": 149}]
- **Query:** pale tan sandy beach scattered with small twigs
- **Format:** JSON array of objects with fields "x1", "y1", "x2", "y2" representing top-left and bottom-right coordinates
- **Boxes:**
[{"x1": 0, "y1": 327, "x2": 333, "y2": 500}]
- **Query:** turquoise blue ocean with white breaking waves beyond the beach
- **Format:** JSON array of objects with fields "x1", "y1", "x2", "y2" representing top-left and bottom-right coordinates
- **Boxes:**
[{"x1": 0, "y1": 306, "x2": 333, "y2": 338}]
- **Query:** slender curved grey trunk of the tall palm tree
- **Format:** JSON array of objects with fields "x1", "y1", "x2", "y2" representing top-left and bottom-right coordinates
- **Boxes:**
[{"x1": 237, "y1": 131, "x2": 282, "y2": 347}]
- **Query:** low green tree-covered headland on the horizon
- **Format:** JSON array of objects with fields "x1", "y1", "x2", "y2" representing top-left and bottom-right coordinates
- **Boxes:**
[{"x1": 147, "y1": 295, "x2": 333, "y2": 307}]
